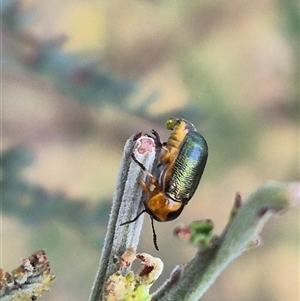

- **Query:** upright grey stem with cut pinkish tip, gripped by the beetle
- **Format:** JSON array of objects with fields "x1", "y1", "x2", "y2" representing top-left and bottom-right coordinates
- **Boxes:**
[{"x1": 89, "y1": 133, "x2": 156, "y2": 301}]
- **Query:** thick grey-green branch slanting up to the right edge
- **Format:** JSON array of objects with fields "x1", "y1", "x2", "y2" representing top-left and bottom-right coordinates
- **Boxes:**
[{"x1": 152, "y1": 182, "x2": 300, "y2": 301}]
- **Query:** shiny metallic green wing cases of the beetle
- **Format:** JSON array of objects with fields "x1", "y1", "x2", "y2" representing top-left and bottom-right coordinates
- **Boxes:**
[{"x1": 159, "y1": 130, "x2": 208, "y2": 205}]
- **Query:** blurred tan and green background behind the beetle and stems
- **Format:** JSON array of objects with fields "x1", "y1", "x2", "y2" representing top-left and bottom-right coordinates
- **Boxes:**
[{"x1": 1, "y1": 0, "x2": 299, "y2": 301}]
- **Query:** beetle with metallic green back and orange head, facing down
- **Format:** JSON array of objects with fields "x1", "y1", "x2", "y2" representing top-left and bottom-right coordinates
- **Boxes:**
[{"x1": 122, "y1": 119, "x2": 208, "y2": 250}]
